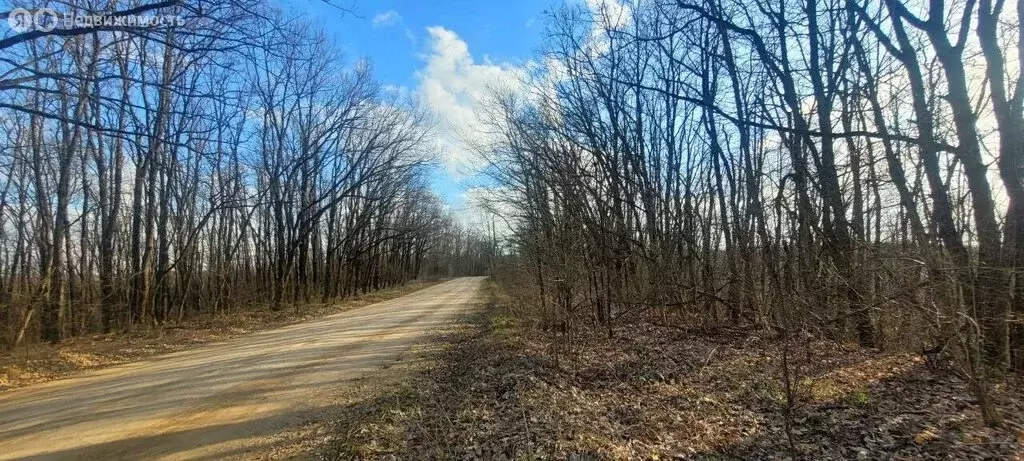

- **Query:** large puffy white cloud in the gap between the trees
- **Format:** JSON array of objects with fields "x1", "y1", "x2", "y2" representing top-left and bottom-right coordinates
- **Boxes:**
[{"x1": 417, "y1": 26, "x2": 526, "y2": 177}]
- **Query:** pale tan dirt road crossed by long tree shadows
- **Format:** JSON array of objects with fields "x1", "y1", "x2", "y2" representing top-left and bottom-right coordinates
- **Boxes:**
[{"x1": 0, "y1": 278, "x2": 483, "y2": 460}]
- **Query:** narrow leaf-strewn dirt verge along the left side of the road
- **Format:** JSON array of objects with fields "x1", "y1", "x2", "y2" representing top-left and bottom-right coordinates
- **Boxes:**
[{"x1": 0, "y1": 281, "x2": 440, "y2": 392}]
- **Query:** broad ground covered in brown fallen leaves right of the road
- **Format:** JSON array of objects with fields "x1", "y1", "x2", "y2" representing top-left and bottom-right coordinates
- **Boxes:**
[{"x1": 319, "y1": 286, "x2": 1024, "y2": 460}]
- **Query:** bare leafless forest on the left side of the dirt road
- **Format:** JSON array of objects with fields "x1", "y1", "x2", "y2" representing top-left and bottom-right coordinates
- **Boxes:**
[{"x1": 0, "y1": 0, "x2": 490, "y2": 346}]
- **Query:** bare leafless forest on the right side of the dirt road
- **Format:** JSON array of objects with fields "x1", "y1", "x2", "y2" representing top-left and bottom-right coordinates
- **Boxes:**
[{"x1": 479, "y1": 0, "x2": 1024, "y2": 425}]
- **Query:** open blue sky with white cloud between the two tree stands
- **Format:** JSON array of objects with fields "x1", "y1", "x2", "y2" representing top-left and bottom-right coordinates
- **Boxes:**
[{"x1": 276, "y1": 0, "x2": 558, "y2": 209}]
